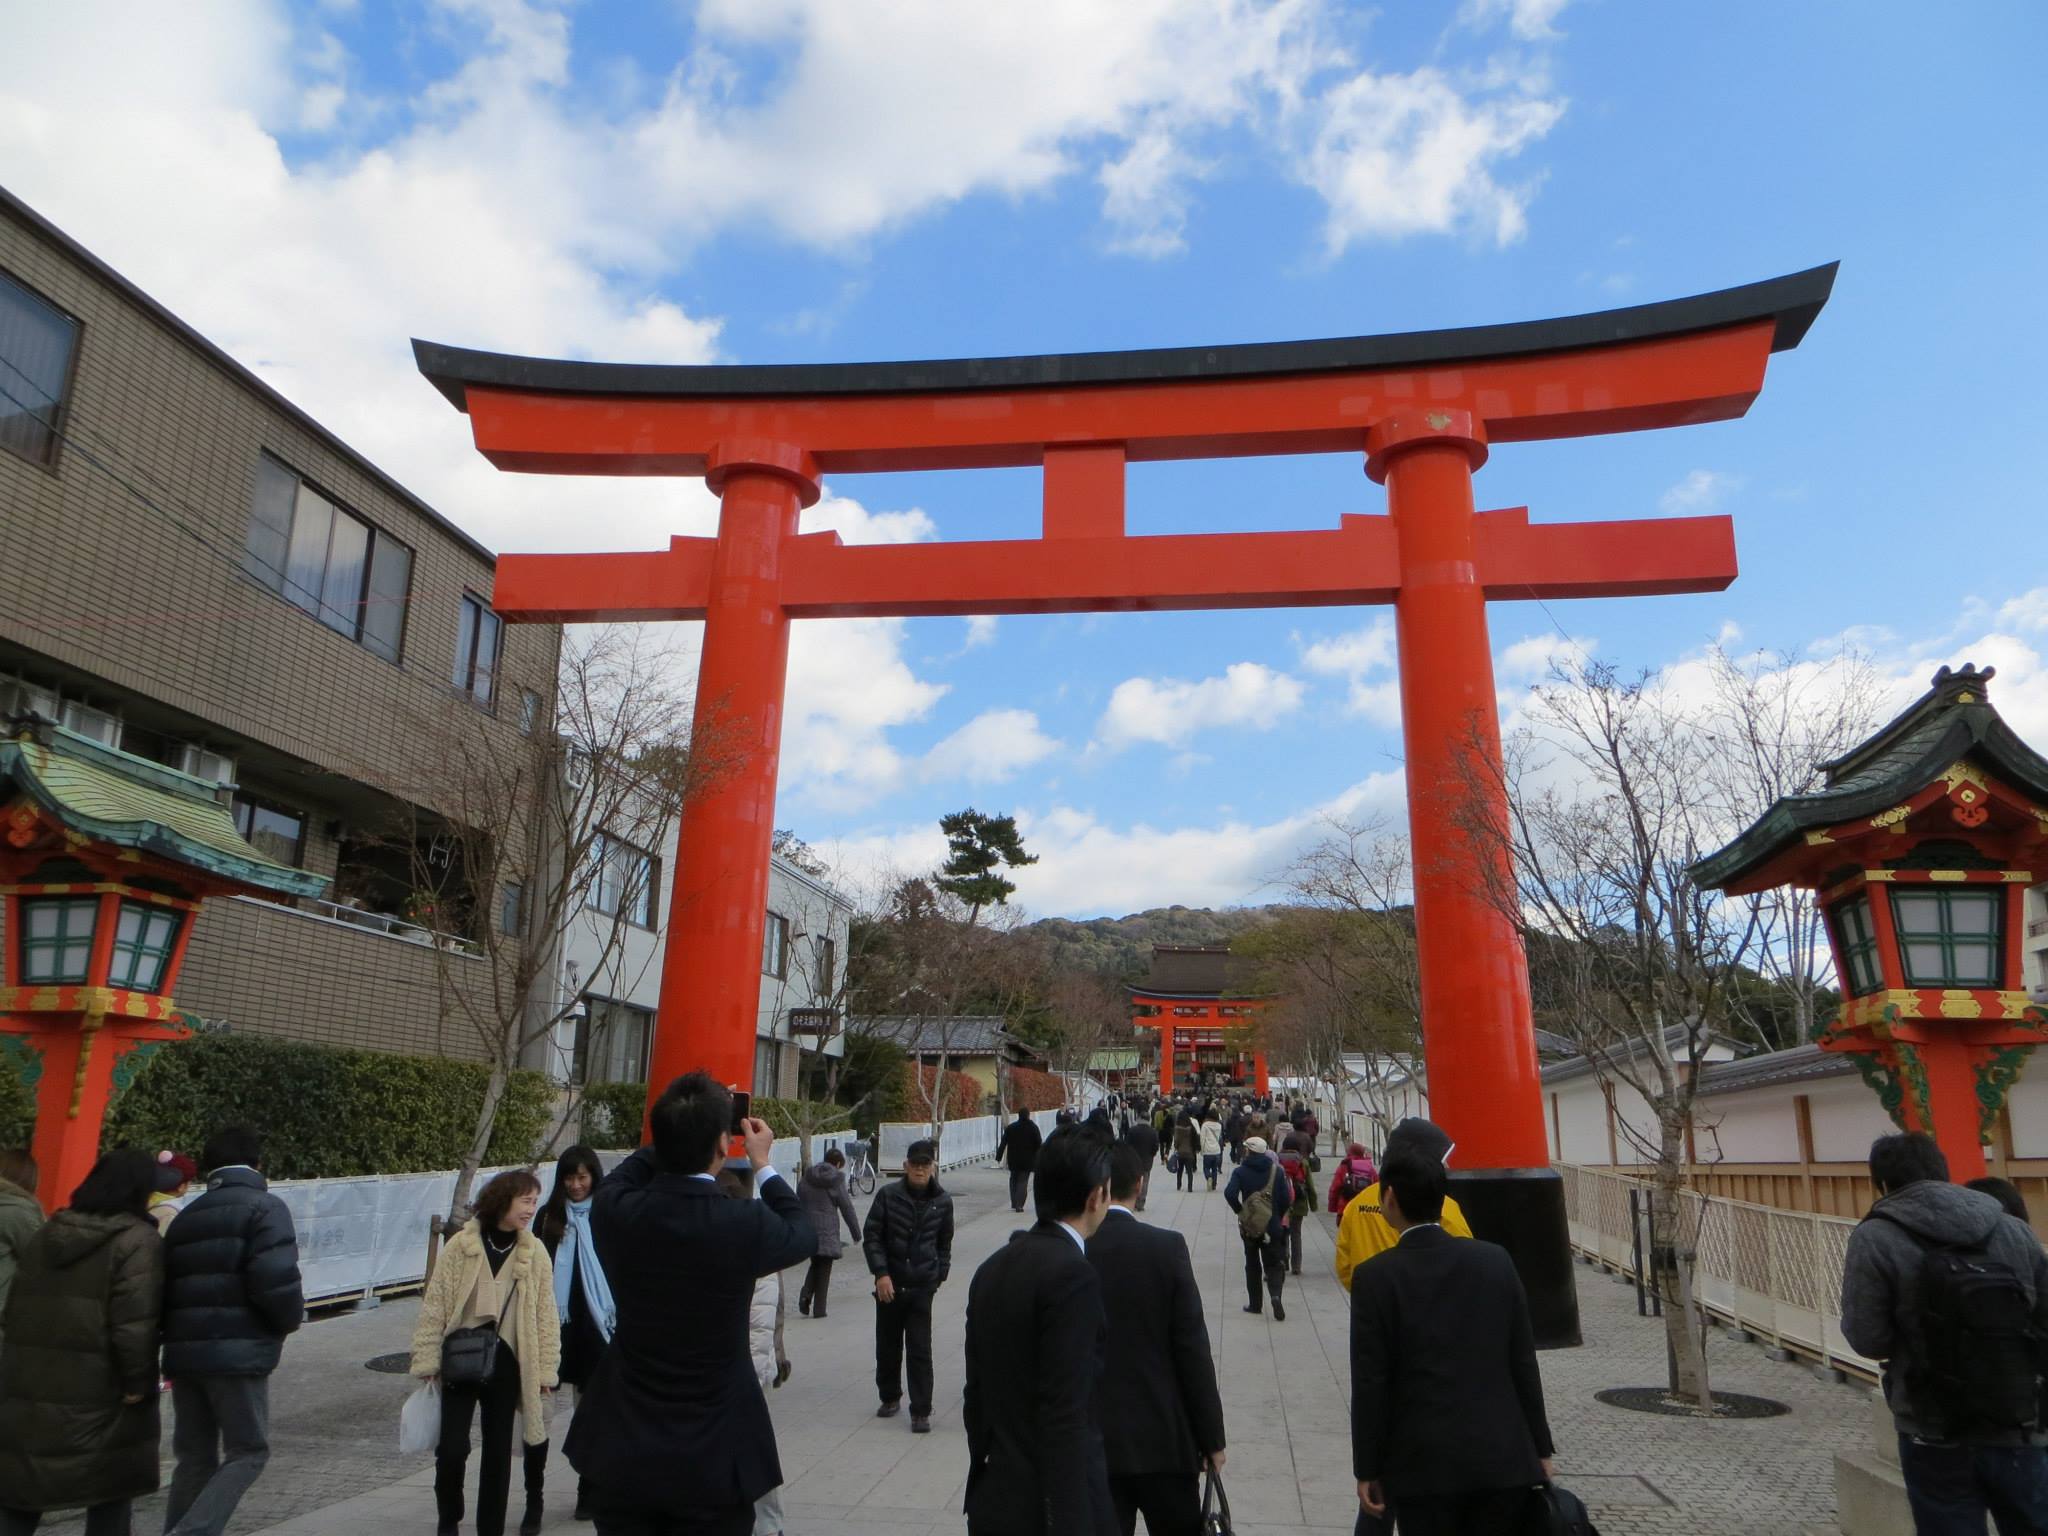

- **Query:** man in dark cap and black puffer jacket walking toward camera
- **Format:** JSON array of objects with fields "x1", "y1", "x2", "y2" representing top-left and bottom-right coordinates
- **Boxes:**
[{"x1": 860, "y1": 1141, "x2": 952, "y2": 1434}]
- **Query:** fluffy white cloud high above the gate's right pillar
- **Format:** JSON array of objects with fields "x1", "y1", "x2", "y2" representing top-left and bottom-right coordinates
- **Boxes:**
[{"x1": 1300, "y1": 68, "x2": 1565, "y2": 256}]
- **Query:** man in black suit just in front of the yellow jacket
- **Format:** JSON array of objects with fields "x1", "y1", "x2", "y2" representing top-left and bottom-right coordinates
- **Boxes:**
[{"x1": 1352, "y1": 1151, "x2": 1550, "y2": 1536}]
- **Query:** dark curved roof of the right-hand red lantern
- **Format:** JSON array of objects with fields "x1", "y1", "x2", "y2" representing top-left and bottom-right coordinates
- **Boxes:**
[{"x1": 1692, "y1": 666, "x2": 2048, "y2": 891}]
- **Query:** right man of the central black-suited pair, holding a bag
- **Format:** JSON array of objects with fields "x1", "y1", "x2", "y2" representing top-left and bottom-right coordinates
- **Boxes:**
[{"x1": 1087, "y1": 1139, "x2": 1223, "y2": 1536}]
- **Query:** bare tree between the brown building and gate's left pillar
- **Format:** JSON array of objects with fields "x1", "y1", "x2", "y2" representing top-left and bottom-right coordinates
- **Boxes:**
[{"x1": 381, "y1": 627, "x2": 707, "y2": 1210}]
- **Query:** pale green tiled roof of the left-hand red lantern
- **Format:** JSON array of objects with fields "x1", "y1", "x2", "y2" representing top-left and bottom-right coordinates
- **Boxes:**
[{"x1": 0, "y1": 721, "x2": 328, "y2": 897}]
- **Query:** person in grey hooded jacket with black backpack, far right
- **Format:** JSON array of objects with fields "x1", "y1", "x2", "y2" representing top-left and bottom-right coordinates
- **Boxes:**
[{"x1": 1841, "y1": 1130, "x2": 2048, "y2": 1536}]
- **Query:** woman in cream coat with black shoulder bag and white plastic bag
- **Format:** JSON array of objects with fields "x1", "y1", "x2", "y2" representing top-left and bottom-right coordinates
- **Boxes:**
[{"x1": 412, "y1": 1169, "x2": 561, "y2": 1536}]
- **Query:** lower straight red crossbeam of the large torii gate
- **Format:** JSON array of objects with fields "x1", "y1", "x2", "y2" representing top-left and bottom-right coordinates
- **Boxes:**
[{"x1": 496, "y1": 508, "x2": 1735, "y2": 623}]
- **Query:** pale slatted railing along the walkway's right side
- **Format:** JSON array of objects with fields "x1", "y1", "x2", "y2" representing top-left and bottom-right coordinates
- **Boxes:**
[{"x1": 1556, "y1": 1163, "x2": 1878, "y2": 1376}]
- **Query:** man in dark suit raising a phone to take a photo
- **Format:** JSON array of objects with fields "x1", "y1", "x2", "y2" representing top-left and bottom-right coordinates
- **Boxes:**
[{"x1": 565, "y1": 1071, "x2": 817, "y2": 1536}]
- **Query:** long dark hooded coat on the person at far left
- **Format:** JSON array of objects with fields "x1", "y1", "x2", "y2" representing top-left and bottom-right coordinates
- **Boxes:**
[{"x1": 0, "y1": 1210, "x2": 164, "y2": 1509}]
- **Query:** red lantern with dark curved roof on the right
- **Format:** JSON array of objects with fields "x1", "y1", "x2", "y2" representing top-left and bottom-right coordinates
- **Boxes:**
[{"x1": 1694, "y1": 666, "x2": 2048, "y2": 1182}]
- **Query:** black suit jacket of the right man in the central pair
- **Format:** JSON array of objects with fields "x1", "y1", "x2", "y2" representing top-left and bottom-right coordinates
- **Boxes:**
[{"x1": 1087, "y1": 1210, "x2": 1223, "y2": 1477}]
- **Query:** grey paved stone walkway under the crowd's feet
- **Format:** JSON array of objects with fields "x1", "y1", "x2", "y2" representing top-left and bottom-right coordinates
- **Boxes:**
[{"x1": 56, "y1": 1167, "x2": 1868, "y2": 1536}]
